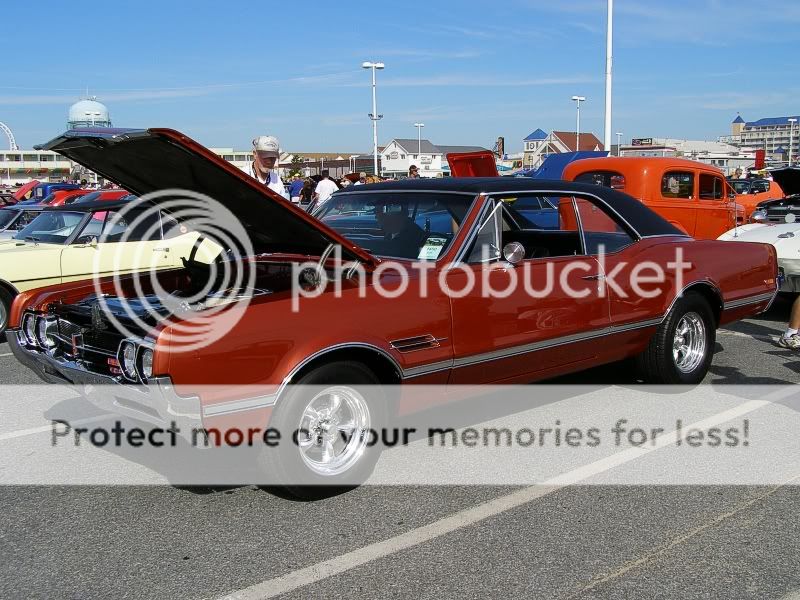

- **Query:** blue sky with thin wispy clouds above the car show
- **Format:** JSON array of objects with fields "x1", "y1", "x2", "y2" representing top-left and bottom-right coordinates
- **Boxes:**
[{"x1": 0, "y1": 0, "x2": 800, "y2": 152}]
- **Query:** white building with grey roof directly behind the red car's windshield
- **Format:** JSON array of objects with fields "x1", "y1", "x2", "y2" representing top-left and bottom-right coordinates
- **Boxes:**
[{"x1": 381, "y1": 138, "x2": 486, "y2": 178}]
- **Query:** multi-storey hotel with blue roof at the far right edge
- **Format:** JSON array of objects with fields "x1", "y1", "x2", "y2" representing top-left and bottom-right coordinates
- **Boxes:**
[{"x1": 719, "y1": 115, "x2": 800, "y2": 163}]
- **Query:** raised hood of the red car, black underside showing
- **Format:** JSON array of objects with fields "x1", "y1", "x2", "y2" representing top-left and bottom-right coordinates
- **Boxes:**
[{"x1": 36, "y1": 128, "x2": 377, "y2": 264}]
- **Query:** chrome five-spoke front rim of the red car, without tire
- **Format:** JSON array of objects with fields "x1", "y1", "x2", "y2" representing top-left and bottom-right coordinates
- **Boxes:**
[{"x1": 297, "y1": 386, "x2": 370, "y2": 477}]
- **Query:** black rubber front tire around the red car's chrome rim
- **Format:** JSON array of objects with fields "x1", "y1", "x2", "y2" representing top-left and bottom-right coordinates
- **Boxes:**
[{"x1": 259, "y1": 361, "x2": 387, "y2": 499}]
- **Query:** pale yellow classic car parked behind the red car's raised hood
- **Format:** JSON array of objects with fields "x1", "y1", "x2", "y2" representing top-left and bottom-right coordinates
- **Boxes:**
[{"x1": 0, "y1": 201, "x2": 216, "y2": 335}]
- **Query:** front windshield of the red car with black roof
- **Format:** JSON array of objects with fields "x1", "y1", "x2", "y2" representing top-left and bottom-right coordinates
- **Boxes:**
[{"x1": 314, "y1": 192, "x2": 473, "y2": 260}]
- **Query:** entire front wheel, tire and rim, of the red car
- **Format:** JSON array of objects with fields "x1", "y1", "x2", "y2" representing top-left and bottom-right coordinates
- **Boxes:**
[{"x1": 260, "y1": 362, "x2": 387, "y2": 498}]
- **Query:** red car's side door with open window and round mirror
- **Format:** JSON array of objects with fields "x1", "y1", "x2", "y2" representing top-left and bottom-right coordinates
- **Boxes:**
[{"x1": 447, "y1": 193, "x2": 609, "y2": 384}]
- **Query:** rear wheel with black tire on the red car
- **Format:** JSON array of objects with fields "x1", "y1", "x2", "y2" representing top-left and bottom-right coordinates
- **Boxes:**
[{"x1": 636, "y1": 292, "x2": 717, "y2": 385}]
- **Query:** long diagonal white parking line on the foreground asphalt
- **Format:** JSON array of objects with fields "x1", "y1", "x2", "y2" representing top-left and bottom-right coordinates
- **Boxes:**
[{"x1": 224, "y1": 392, "x2": 786, "y2": 600}]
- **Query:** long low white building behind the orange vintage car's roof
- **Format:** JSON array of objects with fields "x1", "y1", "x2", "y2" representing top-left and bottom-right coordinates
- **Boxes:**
[{"x1": 619, "y1": 138, "x2": 755, "y2": 175}]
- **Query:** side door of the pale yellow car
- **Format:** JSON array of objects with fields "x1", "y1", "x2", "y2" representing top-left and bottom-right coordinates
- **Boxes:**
[{"x1": 61, "y1": 211, "x2": 170, "y2": 281}]
